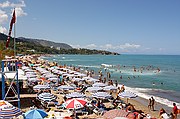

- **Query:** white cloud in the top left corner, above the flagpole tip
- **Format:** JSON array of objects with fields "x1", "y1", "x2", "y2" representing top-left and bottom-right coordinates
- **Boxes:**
[{"x1": 0, "y1": 0, "x2": 26, "y2": 8}]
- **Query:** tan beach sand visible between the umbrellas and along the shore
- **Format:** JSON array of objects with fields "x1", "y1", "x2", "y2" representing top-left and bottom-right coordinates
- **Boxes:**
[{"x1": 1, "y1": 56, "x2": 179, "y2": 119}]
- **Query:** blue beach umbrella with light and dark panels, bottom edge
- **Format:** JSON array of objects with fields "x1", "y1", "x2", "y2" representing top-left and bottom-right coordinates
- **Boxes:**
[{"x1": 24, "y1": 109, "x2": 48, "y2": 119}]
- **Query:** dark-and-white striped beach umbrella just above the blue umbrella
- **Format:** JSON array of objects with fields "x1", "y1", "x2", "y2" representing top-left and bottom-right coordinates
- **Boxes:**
[{"x1": 37, "y1": 93, "x2": 57, "y2": 102}]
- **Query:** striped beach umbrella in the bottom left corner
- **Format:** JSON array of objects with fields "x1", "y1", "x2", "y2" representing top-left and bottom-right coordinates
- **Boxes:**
[{"x1": 0, "y1": 106, "x2": 22, "y2": 119}]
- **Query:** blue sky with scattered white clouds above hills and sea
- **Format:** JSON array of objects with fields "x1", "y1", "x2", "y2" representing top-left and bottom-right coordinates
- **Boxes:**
[{"x1": 0, "y1": 0, "x2": 180, "y2": 55}]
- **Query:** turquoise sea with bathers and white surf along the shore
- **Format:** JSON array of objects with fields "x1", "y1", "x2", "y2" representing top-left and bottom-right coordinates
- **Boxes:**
[{"x1": 43, "y1": 55, "x2": 180, "y2": 107}]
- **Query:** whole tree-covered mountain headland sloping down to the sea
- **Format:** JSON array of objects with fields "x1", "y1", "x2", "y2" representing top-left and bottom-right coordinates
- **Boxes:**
[{"x1": 0, "y1": 33, "x2": 119, "y2": 55}]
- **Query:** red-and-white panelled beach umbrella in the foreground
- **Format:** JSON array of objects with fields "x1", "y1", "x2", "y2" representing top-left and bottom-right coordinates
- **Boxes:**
[{"x1": 65, "y1": 98, "x2": 86, "y2": 109}]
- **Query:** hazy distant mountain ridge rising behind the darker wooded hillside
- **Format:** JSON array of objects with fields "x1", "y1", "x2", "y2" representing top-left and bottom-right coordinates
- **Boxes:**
[{"x1": 0, "y1": 33, "x2": 72, "y2": 49}]
